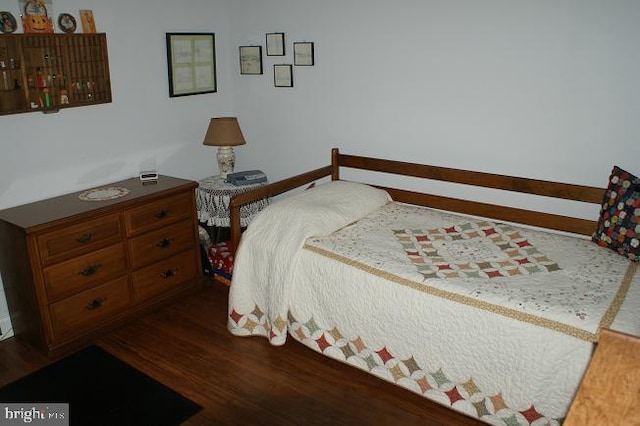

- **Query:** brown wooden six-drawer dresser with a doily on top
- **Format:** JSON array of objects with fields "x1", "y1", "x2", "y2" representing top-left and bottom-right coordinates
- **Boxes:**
[{"x1": 0, "y1": 176, "x2": 203, "y2": 357}]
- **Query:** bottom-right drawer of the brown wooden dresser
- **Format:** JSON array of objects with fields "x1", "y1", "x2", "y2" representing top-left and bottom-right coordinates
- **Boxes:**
[{"x1": 133, "y1": 250, "x2": 198, "y2": 302}]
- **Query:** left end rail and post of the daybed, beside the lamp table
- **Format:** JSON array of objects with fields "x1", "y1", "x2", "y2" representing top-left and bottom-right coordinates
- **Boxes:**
[{"x1": 229, "y1": 166, "x2": 334, "y2": 253}]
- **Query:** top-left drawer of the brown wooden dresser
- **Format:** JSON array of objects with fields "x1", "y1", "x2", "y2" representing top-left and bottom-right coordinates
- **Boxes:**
[{"x1": 37, "y1": 214, "x2": 123, "y2": 264}]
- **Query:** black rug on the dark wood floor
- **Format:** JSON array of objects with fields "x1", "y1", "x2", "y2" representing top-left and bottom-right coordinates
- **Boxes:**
[{"x1": 0, "y1": 346, "x2": 202, "y2": 426}]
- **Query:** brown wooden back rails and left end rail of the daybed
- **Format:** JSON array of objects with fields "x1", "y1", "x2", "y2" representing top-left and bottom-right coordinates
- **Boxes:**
[{"x1": 230, "y1": 148, "x2": 605, "y2": 252}]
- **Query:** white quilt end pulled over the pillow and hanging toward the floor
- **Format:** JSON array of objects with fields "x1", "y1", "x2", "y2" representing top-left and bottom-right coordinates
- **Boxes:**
[{"x1": 229, "y1": 181, "x2": 391, "y2": 345}]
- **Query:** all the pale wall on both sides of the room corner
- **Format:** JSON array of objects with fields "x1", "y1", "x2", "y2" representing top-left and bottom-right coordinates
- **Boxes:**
[{"x1": 0, "y1": 0, "x2": 640, "y2": 340}]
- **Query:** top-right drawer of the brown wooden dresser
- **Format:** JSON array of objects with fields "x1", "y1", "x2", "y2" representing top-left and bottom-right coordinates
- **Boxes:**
[{"x1": 124, "y1": 192, "x2": 195, "y2": 235}]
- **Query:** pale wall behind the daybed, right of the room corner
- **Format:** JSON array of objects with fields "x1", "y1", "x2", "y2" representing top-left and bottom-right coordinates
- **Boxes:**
[{"x1": 232, "y1": 0, "x2": 640, "y2": 203}]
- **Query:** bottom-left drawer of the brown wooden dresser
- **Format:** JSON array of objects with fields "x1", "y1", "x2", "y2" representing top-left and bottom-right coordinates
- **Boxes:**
[{"x1": 49, "y1": 276, "x2": 132, "y2": 339}]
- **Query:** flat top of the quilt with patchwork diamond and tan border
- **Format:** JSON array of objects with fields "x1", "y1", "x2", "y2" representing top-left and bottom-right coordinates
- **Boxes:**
[{"x1": 305, "y1": 203, "x2": 640, "y2": 342}]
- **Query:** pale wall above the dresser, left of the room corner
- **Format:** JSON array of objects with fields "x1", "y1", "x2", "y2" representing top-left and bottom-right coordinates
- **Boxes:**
[{"x1": 0, "y1": 0, "x2": 236, "y2": 340}]
